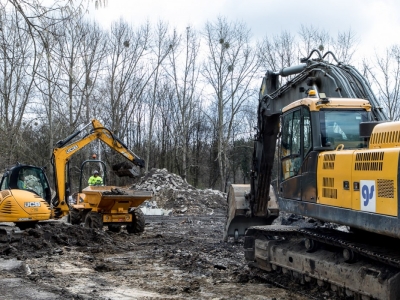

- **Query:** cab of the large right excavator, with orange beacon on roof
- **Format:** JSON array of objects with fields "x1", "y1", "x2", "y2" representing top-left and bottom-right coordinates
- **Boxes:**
[{"x1": 278, "y1": 98, "x2": 371, "y2": 203}]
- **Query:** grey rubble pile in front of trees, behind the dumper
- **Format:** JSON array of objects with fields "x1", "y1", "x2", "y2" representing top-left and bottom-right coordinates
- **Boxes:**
[{"x1": 131, "y1": 169, "x2": 227, "y2": 215}]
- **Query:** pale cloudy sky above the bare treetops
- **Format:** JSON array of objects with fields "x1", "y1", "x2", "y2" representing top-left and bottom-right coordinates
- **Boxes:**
[{"x1": 88, "y1": 0, "x2": 400, "y2": 62}]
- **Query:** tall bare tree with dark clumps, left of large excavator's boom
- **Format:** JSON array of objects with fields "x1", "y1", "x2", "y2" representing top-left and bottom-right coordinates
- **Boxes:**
[{"x1": 203, "y1": 18, "x2": 259, "y2": 191}]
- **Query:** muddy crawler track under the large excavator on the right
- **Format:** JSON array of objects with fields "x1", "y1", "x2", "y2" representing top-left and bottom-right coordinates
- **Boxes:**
[{"x1": 244, "y1": 225, "x2": 400, "y2": 299}]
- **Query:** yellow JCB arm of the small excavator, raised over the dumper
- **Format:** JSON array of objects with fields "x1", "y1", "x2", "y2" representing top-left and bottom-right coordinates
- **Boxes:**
[{"x1": 52, "y1": 119, "x2": 145, "y2": 218}]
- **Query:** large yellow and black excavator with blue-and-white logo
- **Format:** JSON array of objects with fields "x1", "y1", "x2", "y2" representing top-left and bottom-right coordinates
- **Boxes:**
[{"x1": 224, "y1": 49, "x2": 400, "y2": 300}]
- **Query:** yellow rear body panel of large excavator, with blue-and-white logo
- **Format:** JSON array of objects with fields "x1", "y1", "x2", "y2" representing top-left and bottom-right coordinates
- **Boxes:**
[{"x1": 317, "y1": 148, "x2": 400, "y2": 216}]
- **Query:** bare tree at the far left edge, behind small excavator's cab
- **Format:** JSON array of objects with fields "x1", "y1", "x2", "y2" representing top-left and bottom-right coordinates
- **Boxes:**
[{"x1": 0, "y1": 7, "x2": 37, "y2": 164}]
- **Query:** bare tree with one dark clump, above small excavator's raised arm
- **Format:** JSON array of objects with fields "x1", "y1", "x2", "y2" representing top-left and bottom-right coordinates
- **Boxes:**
[{"x1": 101, "y1": 20, "x2": 150, "y2": 135}]
